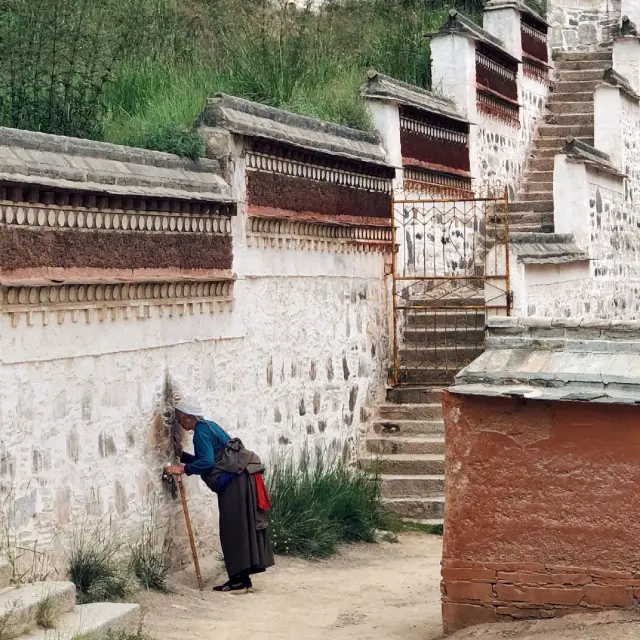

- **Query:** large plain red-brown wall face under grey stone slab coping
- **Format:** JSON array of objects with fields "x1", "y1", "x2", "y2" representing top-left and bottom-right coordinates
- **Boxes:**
[{"x1": 442, "y1": 393, "x2": 640, "y2": 632}]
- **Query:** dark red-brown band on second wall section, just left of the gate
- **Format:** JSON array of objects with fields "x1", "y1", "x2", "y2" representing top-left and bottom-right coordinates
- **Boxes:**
[{"x1": 247, "y1": 171, "x2": 391, "y2": 218}]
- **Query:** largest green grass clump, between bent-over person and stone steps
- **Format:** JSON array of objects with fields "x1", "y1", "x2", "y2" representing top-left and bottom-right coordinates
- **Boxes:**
[{"x1": 268, "y1": 450, "x2": 383, "y2": 558}]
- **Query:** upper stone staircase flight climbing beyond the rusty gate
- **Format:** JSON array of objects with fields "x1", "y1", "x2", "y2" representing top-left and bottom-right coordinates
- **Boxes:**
[{"x1": 509, "y1": 51, "x2": 612, "y2": 233}]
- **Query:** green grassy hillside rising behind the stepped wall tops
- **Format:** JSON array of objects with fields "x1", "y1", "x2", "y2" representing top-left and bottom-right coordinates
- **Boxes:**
[{"x1": 0, "y1": 0, "x2": 544, "y2": 156}]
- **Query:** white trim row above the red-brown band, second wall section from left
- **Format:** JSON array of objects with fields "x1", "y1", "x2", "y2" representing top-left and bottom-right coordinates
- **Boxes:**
[{"x1": 247, "y1": 151, "x2": 391, "y2": 193}]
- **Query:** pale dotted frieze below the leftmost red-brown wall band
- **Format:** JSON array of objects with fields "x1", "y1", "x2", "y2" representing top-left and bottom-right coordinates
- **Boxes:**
[{"x1": 0, "y1": 280, "x2": 233, "y2": 327}]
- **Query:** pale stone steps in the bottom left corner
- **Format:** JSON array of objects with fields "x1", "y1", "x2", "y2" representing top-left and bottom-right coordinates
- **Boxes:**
[{"x1": 0, "y1": 563, "x2": 140, "y2": 640}]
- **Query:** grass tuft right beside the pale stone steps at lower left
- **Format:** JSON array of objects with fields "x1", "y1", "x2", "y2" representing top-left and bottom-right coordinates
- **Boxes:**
[{"x1": 68, "y1": 523, "x2": 130, "y2": 604}]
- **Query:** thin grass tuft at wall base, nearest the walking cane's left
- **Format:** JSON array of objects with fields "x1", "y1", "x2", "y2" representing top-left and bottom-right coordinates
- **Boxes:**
[{"x1": 131, "y1": 516, "x2": 172, "y2": 593}]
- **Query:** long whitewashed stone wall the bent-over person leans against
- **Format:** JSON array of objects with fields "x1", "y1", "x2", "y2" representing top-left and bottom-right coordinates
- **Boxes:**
[{"x1": 0, "y1": 204, "x2": 391, "y2": 560}]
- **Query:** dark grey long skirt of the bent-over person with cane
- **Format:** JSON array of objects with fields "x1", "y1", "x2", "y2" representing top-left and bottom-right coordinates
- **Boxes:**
[{"x1": 218, "y1": 472, "x2": 274, "y2": 578}]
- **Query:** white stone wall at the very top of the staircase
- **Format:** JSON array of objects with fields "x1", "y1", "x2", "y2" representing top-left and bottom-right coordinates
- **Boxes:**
[{"x1": 548, "y1": 0, "x2": 620, "y2": 51}]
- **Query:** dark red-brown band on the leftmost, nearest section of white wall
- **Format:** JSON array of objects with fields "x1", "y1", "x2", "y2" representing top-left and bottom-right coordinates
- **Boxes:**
[{"x1": 0, "y1": 229, "x2": 233, "y2": 272}]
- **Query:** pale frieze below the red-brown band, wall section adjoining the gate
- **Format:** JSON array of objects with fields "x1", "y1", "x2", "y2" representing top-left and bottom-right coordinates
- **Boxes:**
[{"x1": 247, "y1": 216, "x2": 392, "y2": 253}]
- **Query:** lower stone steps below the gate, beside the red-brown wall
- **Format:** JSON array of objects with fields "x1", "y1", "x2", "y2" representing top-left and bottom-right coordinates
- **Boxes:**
[{"x1": 367, "y1": 387, "x2": 444, "y2": 525}]
